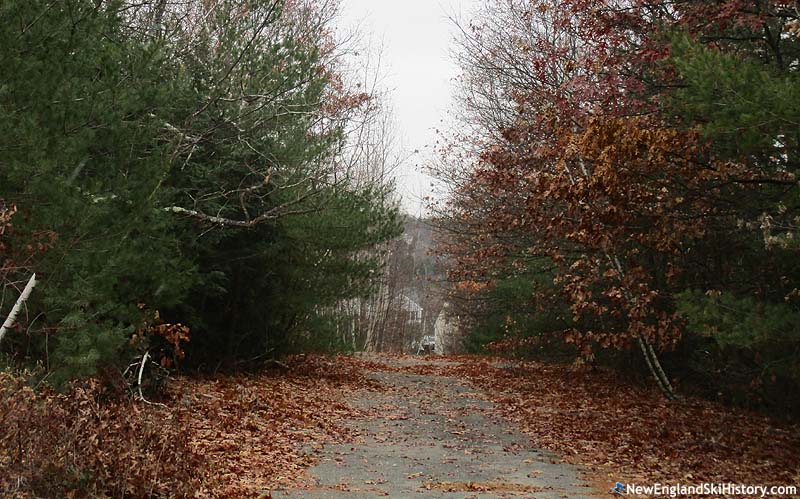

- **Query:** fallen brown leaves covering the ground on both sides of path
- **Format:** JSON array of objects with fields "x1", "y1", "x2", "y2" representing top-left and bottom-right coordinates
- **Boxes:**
[{"x1": 7, "y1": 357, "x2": 800, "y2": 498}]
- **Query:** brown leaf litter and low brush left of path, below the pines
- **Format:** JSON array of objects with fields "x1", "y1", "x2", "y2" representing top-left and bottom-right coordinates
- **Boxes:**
[{"x1": 0, "y1": 356, "x2": 376, "y2": 498}]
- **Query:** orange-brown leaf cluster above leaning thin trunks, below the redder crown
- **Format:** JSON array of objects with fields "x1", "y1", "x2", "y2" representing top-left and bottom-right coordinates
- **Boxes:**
[{"x1": 445, "y1": 116, "x2": 722, "y2": 355}]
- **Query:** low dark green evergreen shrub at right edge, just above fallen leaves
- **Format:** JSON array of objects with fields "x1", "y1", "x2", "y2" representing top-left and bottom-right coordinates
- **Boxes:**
[{"x1": 676, "y1": 291, "x2": 800, "y2": 415}]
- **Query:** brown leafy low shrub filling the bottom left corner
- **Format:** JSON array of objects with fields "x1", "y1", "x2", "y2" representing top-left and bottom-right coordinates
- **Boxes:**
[{"x1": 0, "y1": 372, "x2": 202, "y2": 498}]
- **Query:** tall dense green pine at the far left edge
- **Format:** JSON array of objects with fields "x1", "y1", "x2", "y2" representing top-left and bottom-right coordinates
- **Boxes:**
[{"x1": 0, "y1": 0, "x2": 194, "y2": 379}]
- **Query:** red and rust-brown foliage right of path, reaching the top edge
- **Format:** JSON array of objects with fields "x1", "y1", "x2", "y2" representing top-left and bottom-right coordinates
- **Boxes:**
[{"x1": 434, "y1": 0, "x2": 796, "y2": 368}]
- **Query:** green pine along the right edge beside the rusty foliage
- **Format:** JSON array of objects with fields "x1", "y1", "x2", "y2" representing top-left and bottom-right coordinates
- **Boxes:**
[{"x1": 669, "y1": 32, "x2": 800, "y2": 398}]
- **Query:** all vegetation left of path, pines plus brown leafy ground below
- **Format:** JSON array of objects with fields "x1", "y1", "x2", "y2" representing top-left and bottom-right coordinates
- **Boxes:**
[{"x1": 0, "y1": 0, "x2": 401, "y2": 497}]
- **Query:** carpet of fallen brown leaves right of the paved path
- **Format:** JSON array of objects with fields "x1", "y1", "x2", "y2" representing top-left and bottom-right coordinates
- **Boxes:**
[{"x1": 450, "y1": 358, "x2": 800, "y2": 496}]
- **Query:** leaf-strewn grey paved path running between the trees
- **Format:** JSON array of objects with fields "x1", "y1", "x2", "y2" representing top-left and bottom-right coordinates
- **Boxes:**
[{"x1": 273, "y1": 358, "x2": 592, "y2": 499}]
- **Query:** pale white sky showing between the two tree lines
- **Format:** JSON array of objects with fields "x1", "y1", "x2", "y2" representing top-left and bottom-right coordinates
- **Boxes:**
[{"x1": 332, "y1": 0, "x2": 476, "y2": 215}]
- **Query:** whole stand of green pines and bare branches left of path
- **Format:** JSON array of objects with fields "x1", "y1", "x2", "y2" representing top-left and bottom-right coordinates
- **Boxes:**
[{"x1": 0, "y1": 0, "x2": 399, "y2": 384}]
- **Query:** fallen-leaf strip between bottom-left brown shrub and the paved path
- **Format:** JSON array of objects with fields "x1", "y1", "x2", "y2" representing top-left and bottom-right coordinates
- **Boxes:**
[{"x1": 173, "y1": 356, "x2": 375, "y2": 498}]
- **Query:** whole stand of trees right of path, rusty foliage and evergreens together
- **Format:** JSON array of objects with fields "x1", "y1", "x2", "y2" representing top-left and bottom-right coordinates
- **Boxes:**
[{"x1": 436, "y1": 0, "x2": 800, "y2": 410}]
